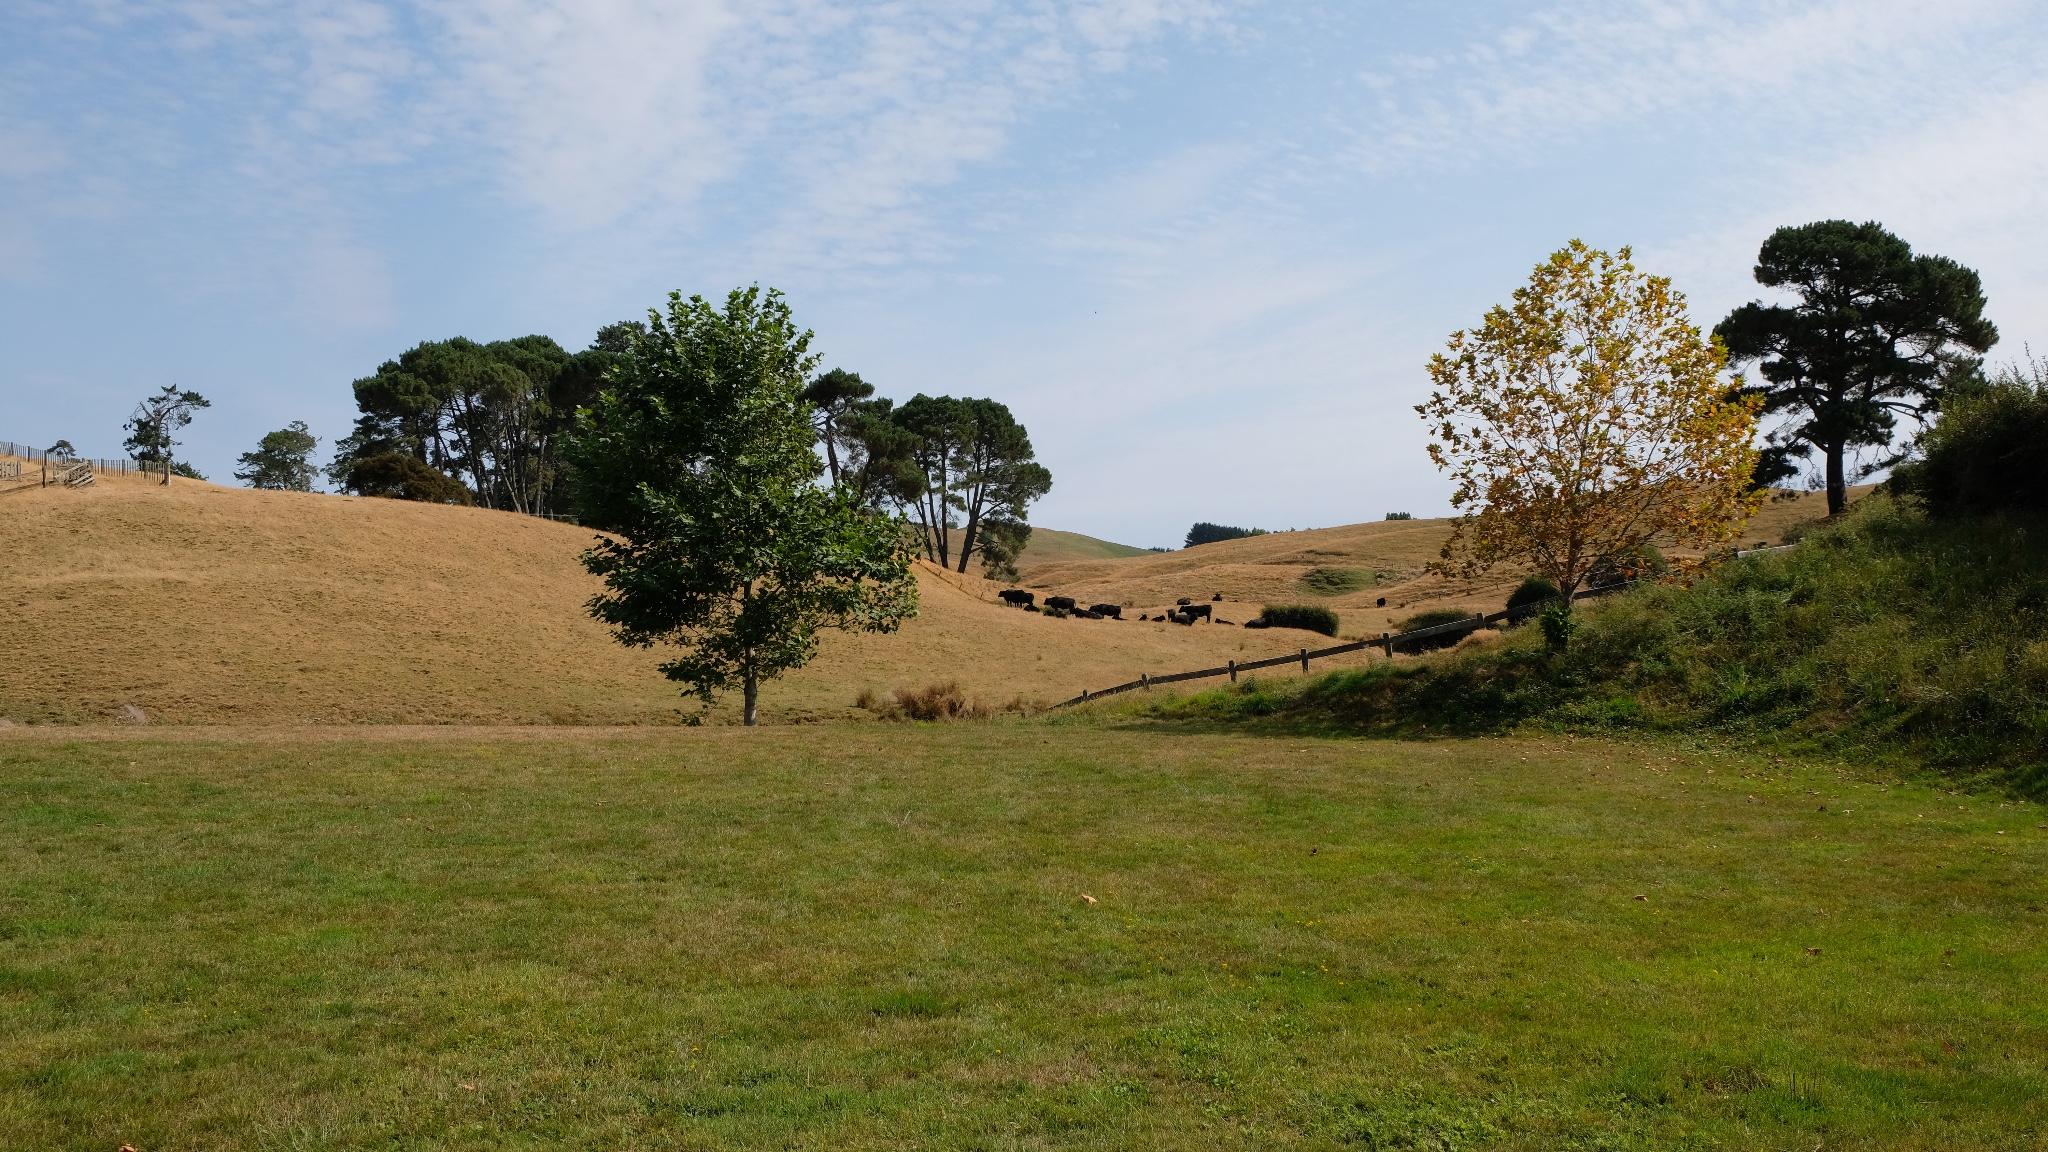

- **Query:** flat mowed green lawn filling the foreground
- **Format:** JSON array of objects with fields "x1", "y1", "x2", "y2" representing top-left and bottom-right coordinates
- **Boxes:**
[{"x1": 0, "y1": 722, "x2": 2048, "y2": 1152}]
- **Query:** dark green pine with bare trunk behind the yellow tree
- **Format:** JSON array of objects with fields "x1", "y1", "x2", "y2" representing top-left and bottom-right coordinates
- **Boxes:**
[{"x1": 1714, "y1": 219, "x2": 1999, "y2": 515}]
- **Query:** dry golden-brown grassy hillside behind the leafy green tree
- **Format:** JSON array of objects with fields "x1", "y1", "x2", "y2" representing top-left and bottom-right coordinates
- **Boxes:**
[{"x1": 0, "y1": 471, "x2": 1359, "y2": 724}]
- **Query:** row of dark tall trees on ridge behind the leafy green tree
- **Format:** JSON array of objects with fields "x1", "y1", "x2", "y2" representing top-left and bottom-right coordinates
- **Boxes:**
[{"x1": 326, "y1": 320, "x2": 1053, "y2": 578}]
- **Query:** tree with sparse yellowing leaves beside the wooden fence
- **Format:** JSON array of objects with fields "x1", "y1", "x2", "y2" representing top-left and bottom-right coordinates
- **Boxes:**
[{"x1": 1415, "y1": 240, "x2": 1763, "y2": 594}]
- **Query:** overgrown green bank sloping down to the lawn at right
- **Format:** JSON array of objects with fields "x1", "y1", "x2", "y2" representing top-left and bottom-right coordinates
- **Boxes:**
[{"x1": 1187, "y1": 496, "x2": 2048, "y2": 793}]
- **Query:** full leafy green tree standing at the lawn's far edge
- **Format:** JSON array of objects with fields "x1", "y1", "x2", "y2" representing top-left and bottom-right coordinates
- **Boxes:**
[{"x1": 567, "y1": 287, "x2": 918, "y2": 724}]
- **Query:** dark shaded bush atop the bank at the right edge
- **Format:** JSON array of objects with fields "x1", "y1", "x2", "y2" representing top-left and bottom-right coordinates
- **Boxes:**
[{"x1": 1890, "y1": 361, "x2": 2048, "y2": 521}]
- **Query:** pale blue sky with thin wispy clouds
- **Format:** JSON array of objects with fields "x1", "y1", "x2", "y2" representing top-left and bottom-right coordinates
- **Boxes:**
[{"x1": 0, "y1": 0, "x2": 2048, "y2": 545}]
